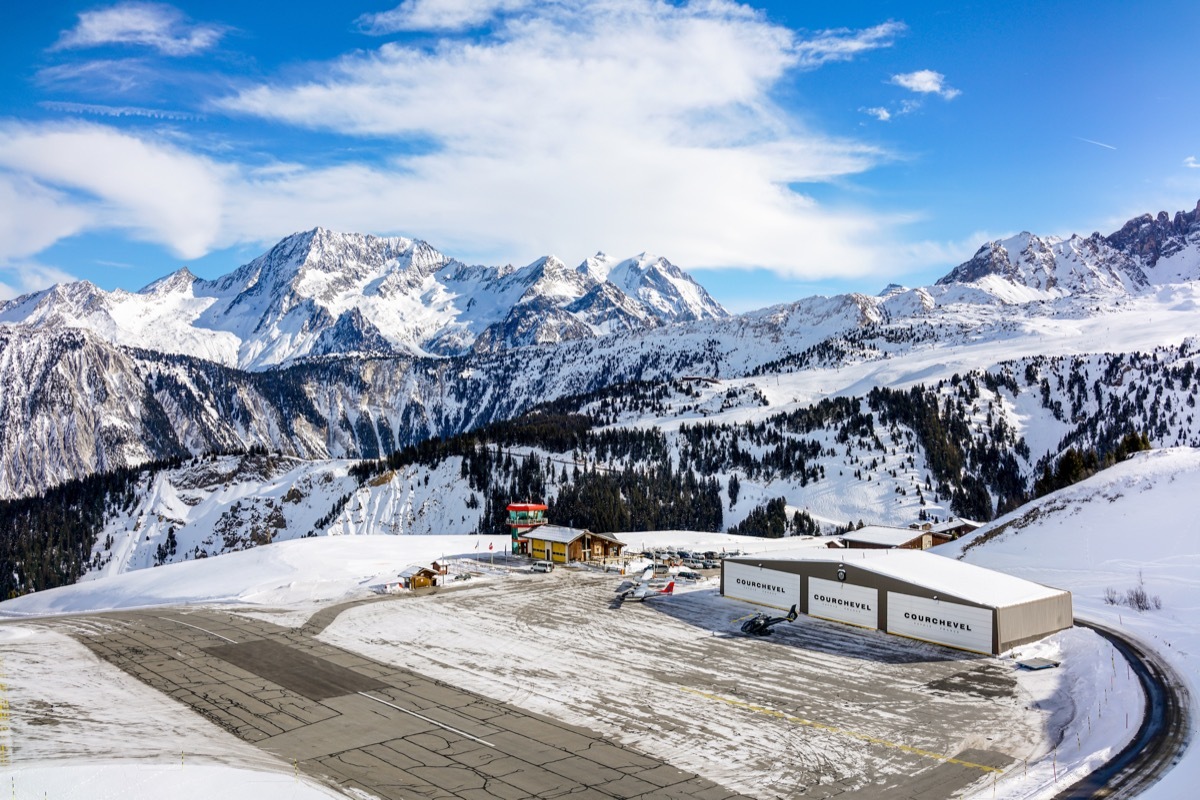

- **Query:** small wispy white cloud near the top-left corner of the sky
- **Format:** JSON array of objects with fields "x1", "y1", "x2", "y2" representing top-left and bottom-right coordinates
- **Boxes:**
[{"x1": 50, "y1": 2, "x2": 226, "y2": 56}]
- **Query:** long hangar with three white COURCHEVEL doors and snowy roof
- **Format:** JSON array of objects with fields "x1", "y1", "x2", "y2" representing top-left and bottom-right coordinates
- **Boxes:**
[{"x1": 721, "y1": 548, "x2": 1074, "y2": 655}]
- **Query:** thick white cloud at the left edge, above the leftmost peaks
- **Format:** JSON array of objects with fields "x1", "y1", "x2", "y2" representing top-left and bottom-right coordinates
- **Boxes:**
[{"x1": 0, "y1": 124, "x2": 226, "y2": 258}]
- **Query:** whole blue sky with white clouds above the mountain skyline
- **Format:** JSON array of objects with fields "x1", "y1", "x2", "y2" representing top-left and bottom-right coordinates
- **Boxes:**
[{"x1": 0, "y1": 0, "x2": 1200, "y2": 311}]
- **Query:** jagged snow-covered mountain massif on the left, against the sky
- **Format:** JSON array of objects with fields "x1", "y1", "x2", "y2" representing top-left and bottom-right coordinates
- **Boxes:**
[{"x1": 0, "y1": 228, "x2": 726, "y2": 369}]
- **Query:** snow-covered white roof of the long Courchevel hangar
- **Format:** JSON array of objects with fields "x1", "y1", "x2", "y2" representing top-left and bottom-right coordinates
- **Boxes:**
[{"x1": 726, "y1": 548, "x2": 1063, "y2": 607}]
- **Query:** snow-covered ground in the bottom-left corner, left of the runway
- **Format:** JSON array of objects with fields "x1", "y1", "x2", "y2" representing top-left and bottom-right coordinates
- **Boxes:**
[{"x1": 0, "y1": 625, "x2": 341, "y2": 800}]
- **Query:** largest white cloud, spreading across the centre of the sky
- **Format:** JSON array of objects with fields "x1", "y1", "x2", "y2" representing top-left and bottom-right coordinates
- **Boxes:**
[{"x1": 221, "y1": 0, "x2": 902, "y2": 280}]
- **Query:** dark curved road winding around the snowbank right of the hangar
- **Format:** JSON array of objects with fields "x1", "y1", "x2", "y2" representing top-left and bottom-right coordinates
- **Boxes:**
[{"x1": 1056, "y1": 620, "x2": 1190, "y2": 800}]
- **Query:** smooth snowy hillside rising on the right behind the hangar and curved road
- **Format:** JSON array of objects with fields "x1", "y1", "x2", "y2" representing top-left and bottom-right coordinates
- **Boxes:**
[{"x1": 935, "y1": 447, "x2": 1200, "y2": 800}]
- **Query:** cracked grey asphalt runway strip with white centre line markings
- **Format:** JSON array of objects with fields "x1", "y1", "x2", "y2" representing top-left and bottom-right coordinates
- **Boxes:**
[{"x1": 63, "y1": 609, "x2": 738, "y2": 800}]
